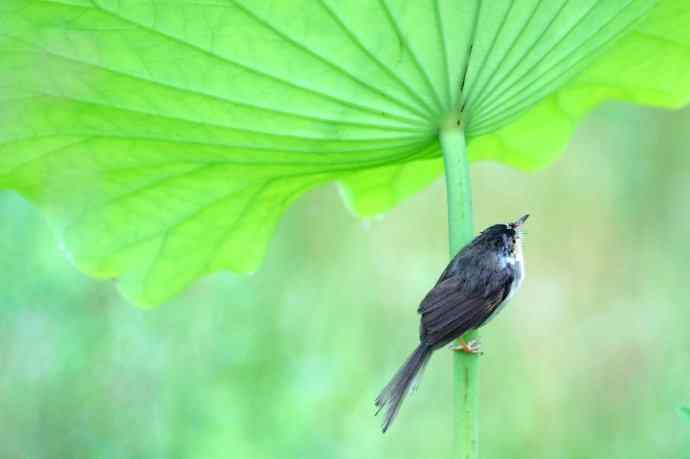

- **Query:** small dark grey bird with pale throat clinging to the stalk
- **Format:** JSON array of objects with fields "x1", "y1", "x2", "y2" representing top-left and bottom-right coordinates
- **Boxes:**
[{"x1": 376, "y1": 215, "x2": 529, "y2": 433}]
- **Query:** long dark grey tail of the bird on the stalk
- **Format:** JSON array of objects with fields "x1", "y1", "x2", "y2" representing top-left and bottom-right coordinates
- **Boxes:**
[{"x1": 376, "y1": 343, "x2": 432, "y2": 433}]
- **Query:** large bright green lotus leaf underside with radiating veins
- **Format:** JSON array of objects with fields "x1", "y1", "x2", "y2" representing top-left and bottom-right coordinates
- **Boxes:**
[{"x1": 0, "y1": 0, "x2": 690, "y2": 305}]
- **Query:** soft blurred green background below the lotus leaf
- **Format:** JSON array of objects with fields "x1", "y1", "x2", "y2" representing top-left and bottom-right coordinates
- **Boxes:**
[{"x1": 0, "y1": 105, "x2": 690, "y2": 459}]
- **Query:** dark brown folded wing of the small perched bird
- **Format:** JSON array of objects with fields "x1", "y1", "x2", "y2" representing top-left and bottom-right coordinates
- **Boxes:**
[{"x1": 419, "y1": 270, "x2": 513, "y2": 347}]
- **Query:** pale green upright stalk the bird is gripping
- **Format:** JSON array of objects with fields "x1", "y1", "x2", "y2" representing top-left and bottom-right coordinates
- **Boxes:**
[{"x1": 439, "y1": 117, "x2": 479, "y2": 459}]
